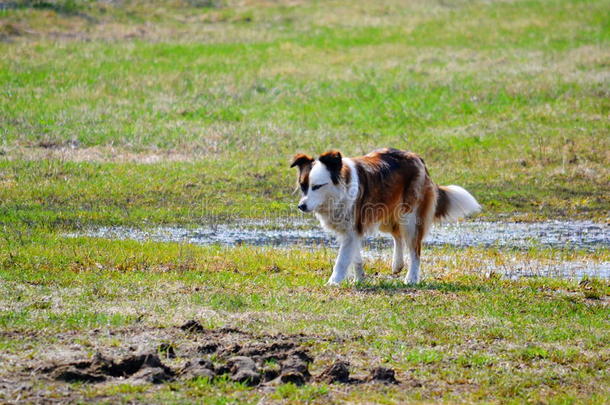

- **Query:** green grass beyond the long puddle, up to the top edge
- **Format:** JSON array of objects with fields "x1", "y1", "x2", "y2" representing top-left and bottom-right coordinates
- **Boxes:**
[{"x1": 0, "y1": 1, "x2": 610, "y2": 227}]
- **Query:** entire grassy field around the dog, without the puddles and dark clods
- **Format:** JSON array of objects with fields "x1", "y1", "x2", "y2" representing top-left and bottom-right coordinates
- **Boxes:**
[{"x1": 0, "y1": 0, "x2": 610, "y2": 404}]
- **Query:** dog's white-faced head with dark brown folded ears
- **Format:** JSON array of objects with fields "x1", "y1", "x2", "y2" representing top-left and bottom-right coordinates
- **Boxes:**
[{"x1": 290, "y1": 150, "x2": 343, "y2": 212}]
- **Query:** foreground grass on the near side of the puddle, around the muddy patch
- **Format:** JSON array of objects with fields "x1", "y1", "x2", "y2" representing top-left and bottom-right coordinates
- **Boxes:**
[{"x1": 0, "y1": 234, "x2": 610, "y2": 403}]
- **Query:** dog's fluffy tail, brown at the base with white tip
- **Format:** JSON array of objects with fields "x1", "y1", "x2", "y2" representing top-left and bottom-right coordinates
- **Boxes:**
[{"x1": 434, "y1": 186, "x2": 481, "y2": 221}]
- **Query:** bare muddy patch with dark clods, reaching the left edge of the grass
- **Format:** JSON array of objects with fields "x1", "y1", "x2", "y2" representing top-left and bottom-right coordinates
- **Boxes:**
[{"x1": 0, "y1": 320, "x2": 404, "y2": 403}]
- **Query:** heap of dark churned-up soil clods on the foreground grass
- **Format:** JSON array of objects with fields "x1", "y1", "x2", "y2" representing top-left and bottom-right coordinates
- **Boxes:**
[{"x1": 43, "y1": 320, "x2": 397, "y2": 386}]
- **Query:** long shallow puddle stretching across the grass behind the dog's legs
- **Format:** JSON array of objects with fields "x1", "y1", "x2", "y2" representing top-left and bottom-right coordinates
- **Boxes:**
[{"x1": 71, "y1": 220, "x2": 610, "y2": 250}]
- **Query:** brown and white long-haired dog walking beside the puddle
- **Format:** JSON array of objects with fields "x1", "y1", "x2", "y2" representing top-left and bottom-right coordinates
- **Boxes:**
[{"x1": 290, "y1": 149, "x2": 481, "y2": 285}]
